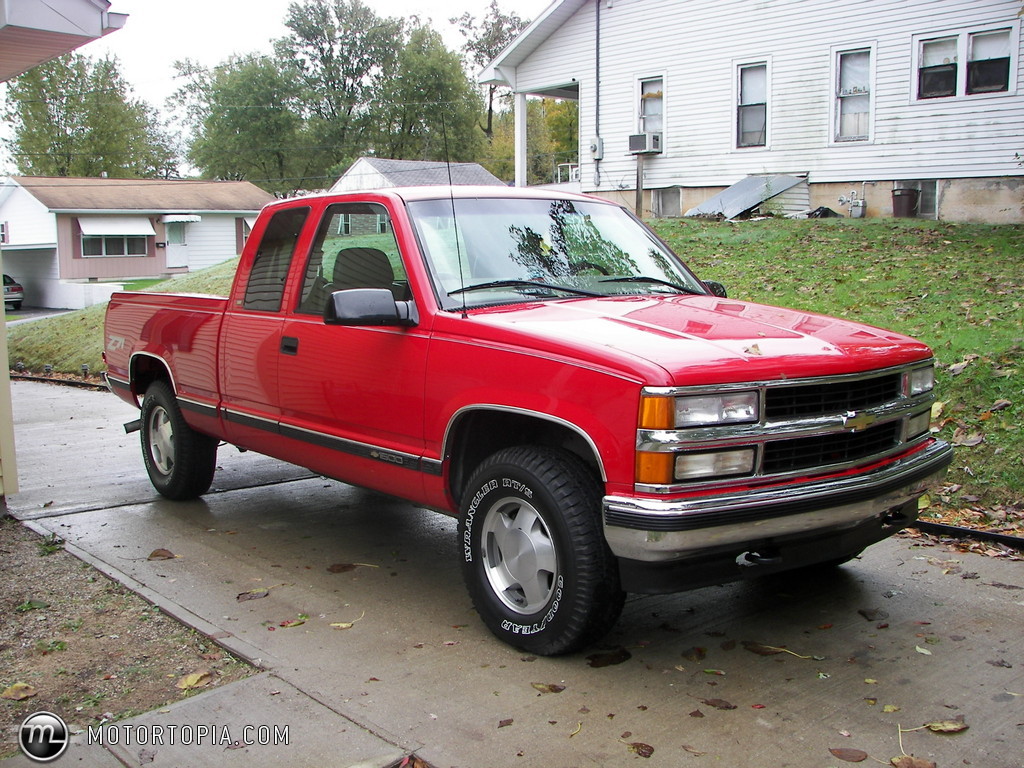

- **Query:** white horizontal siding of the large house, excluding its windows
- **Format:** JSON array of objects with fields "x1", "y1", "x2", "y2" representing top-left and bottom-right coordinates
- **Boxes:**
[{"x1": 515, "y1": 0, "x2": 1024, "y2": 190}]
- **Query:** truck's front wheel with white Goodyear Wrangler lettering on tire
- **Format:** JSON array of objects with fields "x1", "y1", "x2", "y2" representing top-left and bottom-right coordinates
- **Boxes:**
[{"x1": 459, "y1": 446, "x2": 625, "y2": 655}]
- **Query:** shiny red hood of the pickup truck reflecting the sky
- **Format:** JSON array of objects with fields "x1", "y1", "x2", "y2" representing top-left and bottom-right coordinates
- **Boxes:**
[{"x1": 471, "y1": 296, "x2": 931, "y2": 386}]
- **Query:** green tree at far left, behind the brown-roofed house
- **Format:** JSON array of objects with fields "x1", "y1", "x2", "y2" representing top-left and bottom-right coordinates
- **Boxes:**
[{"x1": 4, "y1": 53, "x2": 176, "y2": 178}]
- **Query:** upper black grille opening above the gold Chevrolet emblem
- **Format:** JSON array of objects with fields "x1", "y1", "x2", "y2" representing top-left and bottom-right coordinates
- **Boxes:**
[{"x1": 765, "y1": 373, "x2": 901, "y2": 419}]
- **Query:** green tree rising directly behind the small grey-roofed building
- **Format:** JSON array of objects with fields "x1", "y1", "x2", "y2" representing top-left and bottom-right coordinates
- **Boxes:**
[{"x1": 373, "y1": 26, "x2": 481, "y2": 162}]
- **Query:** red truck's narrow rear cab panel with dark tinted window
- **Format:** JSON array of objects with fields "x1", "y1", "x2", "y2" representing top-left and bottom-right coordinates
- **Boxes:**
[{"x1": 219, "y1": 207, "x2": 309, "y2": 456}]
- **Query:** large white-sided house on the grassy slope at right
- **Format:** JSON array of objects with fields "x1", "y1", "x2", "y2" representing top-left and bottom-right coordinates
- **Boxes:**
[{"x1": 480, "y1": 0, "x2": 1024, "y2": 222}]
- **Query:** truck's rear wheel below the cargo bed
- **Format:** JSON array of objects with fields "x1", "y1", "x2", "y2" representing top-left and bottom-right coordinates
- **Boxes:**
[{"x1": 140, "y1": 381, "x2": 217, "y2": 501}]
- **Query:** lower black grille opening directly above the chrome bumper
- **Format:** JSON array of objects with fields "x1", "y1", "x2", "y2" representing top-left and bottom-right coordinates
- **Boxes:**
[{"x1": 763, "y1": 422, "x2": 900, "y2": 474}]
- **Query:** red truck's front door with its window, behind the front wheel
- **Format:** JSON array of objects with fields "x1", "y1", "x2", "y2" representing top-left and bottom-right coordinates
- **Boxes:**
[{"x1": 279, "y1": 203, "x2": 428, "y2": 496}]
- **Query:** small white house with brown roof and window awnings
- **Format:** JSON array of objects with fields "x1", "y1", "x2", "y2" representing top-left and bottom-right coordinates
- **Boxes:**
[{"x1": 0, "y1": 176, "x2": 273, "y2": 309}]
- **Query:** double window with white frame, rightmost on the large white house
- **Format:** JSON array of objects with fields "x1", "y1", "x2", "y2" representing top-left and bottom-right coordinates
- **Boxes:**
[{"x1": 914, "y1": 24, "x2": 1019, "y2": 99}]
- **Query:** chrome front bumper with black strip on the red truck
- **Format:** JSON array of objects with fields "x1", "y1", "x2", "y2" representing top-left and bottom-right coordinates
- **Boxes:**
[{"x1": 603, "y1": 441, "x2": 952, "y2": 562}]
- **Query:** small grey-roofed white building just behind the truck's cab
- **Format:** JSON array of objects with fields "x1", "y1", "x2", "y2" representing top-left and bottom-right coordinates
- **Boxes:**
[{"x1": 331, "y1": 158, "x2": 502, "y2": 193}]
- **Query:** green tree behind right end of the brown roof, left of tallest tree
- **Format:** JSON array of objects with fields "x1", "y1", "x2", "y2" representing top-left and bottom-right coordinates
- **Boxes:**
[{"x1": 175, "y1": 56, "x2": 311, "y2": 194}]
